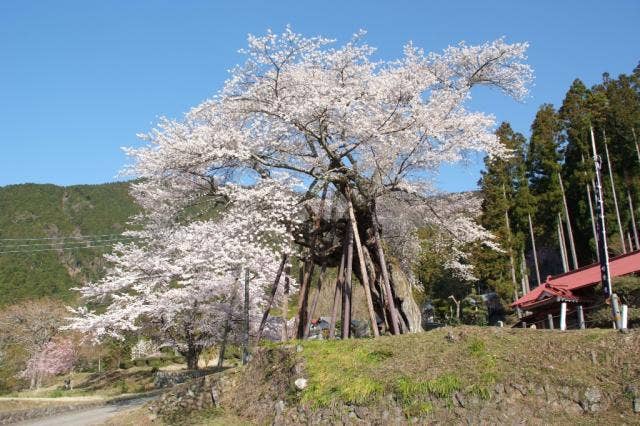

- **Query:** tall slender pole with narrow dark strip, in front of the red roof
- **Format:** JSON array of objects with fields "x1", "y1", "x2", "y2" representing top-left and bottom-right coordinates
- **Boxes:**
[{"x1": 590, "y1": 128, "x2": 622, "y2": 330}]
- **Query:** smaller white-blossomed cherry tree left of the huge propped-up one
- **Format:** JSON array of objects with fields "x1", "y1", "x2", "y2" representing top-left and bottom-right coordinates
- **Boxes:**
[{"x1": 69, "y1": 179, "x2": 295, "y2": 369}]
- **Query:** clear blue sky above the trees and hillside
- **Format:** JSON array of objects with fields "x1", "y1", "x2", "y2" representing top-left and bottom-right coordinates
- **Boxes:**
[{"x1": 0, "y1": 0, "x2": 640, "y2": 190}]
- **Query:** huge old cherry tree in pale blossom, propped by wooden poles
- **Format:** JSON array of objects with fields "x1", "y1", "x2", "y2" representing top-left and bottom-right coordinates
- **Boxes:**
[{"x1": 114, "y1": 28, "x2": 532, "y2": 337}]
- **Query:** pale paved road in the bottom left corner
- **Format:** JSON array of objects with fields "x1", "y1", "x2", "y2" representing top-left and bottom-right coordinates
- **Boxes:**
[{"x1": 17, "y1": 397, "x2": 154, "y2": 426}]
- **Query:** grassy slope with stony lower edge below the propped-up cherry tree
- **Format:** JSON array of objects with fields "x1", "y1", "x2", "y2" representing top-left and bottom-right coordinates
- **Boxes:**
[{"x1": 225, "y1": 327, "x2": 640, "y2": 424}]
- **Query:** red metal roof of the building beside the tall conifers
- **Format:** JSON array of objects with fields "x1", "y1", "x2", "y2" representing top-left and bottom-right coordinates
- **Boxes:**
[{"x1": 511, "y1": 250, "x2": 640, "y2": 309}]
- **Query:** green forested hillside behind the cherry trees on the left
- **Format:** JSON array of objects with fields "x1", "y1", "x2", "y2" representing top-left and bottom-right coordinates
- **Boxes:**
[{"x1": 0, "y1": 182, "x2": 138, "y2": 306}]
